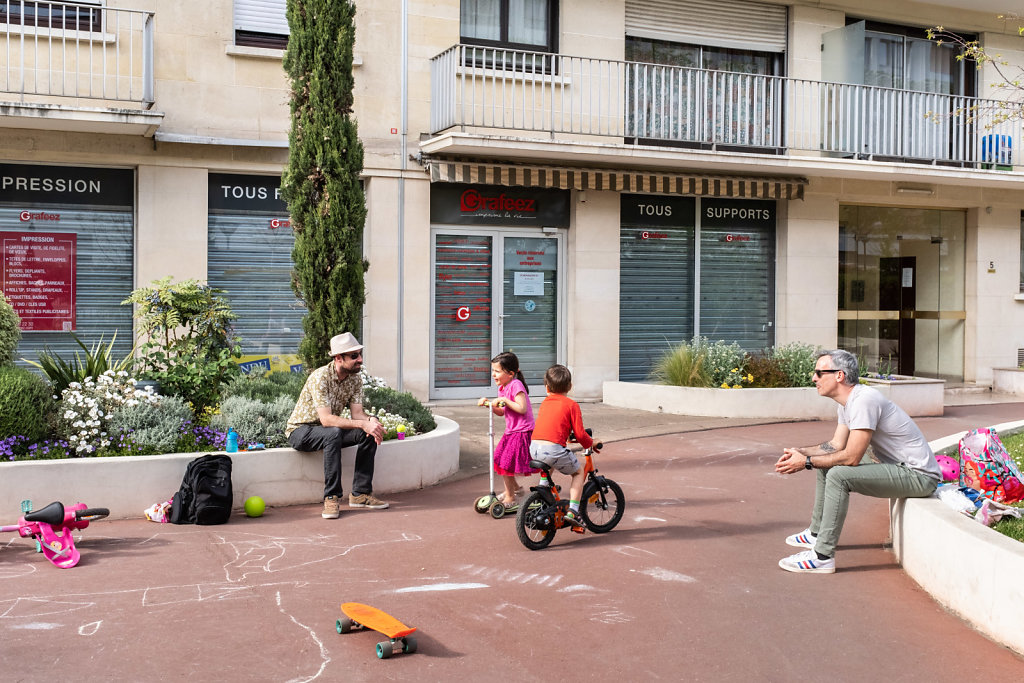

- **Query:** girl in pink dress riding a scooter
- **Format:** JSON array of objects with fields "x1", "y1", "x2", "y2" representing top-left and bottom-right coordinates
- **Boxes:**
[{"x1": 477, "y1": 351, "x2": 537, "y2": 508}]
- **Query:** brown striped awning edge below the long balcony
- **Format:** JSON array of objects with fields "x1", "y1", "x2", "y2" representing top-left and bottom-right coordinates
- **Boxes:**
[{"x1": 424, "y1": 158, "x2": 807, "y2": 200}]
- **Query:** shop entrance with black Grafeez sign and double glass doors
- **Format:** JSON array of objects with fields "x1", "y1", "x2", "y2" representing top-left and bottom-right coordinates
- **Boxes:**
[{"x1": 430, "y1": 183, "x2": 569, "y2": 398}]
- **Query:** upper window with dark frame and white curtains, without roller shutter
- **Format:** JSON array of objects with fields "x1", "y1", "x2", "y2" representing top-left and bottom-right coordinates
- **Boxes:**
[{"x1": 461, "y1": 0, "x2": 558, "y2": 52}]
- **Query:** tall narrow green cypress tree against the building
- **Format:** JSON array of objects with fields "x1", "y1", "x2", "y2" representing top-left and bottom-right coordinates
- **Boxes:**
[{"x1": 282, "y1": 0, "x2": 370, "y2": 371}]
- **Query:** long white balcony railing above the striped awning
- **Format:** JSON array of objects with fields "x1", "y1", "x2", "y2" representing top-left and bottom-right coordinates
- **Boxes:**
[{"x1": 430, "y1": 45, "x2": 1021, "y2": 167}]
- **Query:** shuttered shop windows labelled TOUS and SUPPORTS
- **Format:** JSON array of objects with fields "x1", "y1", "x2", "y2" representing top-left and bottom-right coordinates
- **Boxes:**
[{"x1": 618, "y1": 195, "x2": 776, "y2": 382}]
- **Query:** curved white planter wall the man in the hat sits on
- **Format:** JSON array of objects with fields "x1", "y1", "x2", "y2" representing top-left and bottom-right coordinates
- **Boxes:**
[{"x1": 0, "y1": 416, "x2": 459, "y2": 519}]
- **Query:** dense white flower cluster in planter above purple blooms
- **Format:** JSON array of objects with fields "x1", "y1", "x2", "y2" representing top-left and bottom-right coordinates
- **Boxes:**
[{"x1": 58, "y1": 370, "x2": 160, "y2": 455}]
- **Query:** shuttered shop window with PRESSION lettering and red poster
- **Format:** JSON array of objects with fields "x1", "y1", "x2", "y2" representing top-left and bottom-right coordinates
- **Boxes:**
[{"x1": 0, "y1": 164, "x2": 135, "y2": 360}]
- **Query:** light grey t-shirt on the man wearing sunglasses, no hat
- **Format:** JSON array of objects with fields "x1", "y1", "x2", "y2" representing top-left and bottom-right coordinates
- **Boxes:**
[{"x1": 839, "y1": 384, "x2": 942, "y2": 481}]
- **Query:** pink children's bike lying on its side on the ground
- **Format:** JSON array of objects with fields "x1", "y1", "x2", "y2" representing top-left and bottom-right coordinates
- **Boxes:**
[{"x1": 0, "y1": 501, "x2": 111, "y2": 569}]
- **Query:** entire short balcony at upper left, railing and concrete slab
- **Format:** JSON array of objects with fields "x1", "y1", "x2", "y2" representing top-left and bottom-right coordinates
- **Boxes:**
[{"x1": 0, "y1": 0, "x2": 163, "y2": 135}]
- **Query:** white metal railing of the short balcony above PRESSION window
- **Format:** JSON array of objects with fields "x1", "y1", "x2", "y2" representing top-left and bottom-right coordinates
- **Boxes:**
[{"x1": 0, "y1": 0, "x2": 154, "y2": 108}]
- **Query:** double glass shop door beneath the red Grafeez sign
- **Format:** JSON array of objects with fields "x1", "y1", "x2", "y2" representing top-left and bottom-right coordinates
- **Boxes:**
[{"x1": 430, "y1": 227, "x2": 564, "y2": 398}]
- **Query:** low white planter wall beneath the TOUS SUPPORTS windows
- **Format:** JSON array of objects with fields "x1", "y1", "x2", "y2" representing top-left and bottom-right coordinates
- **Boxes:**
[{"x1": 603, "y1": 382, "x2": 836, "y2": 420}]
